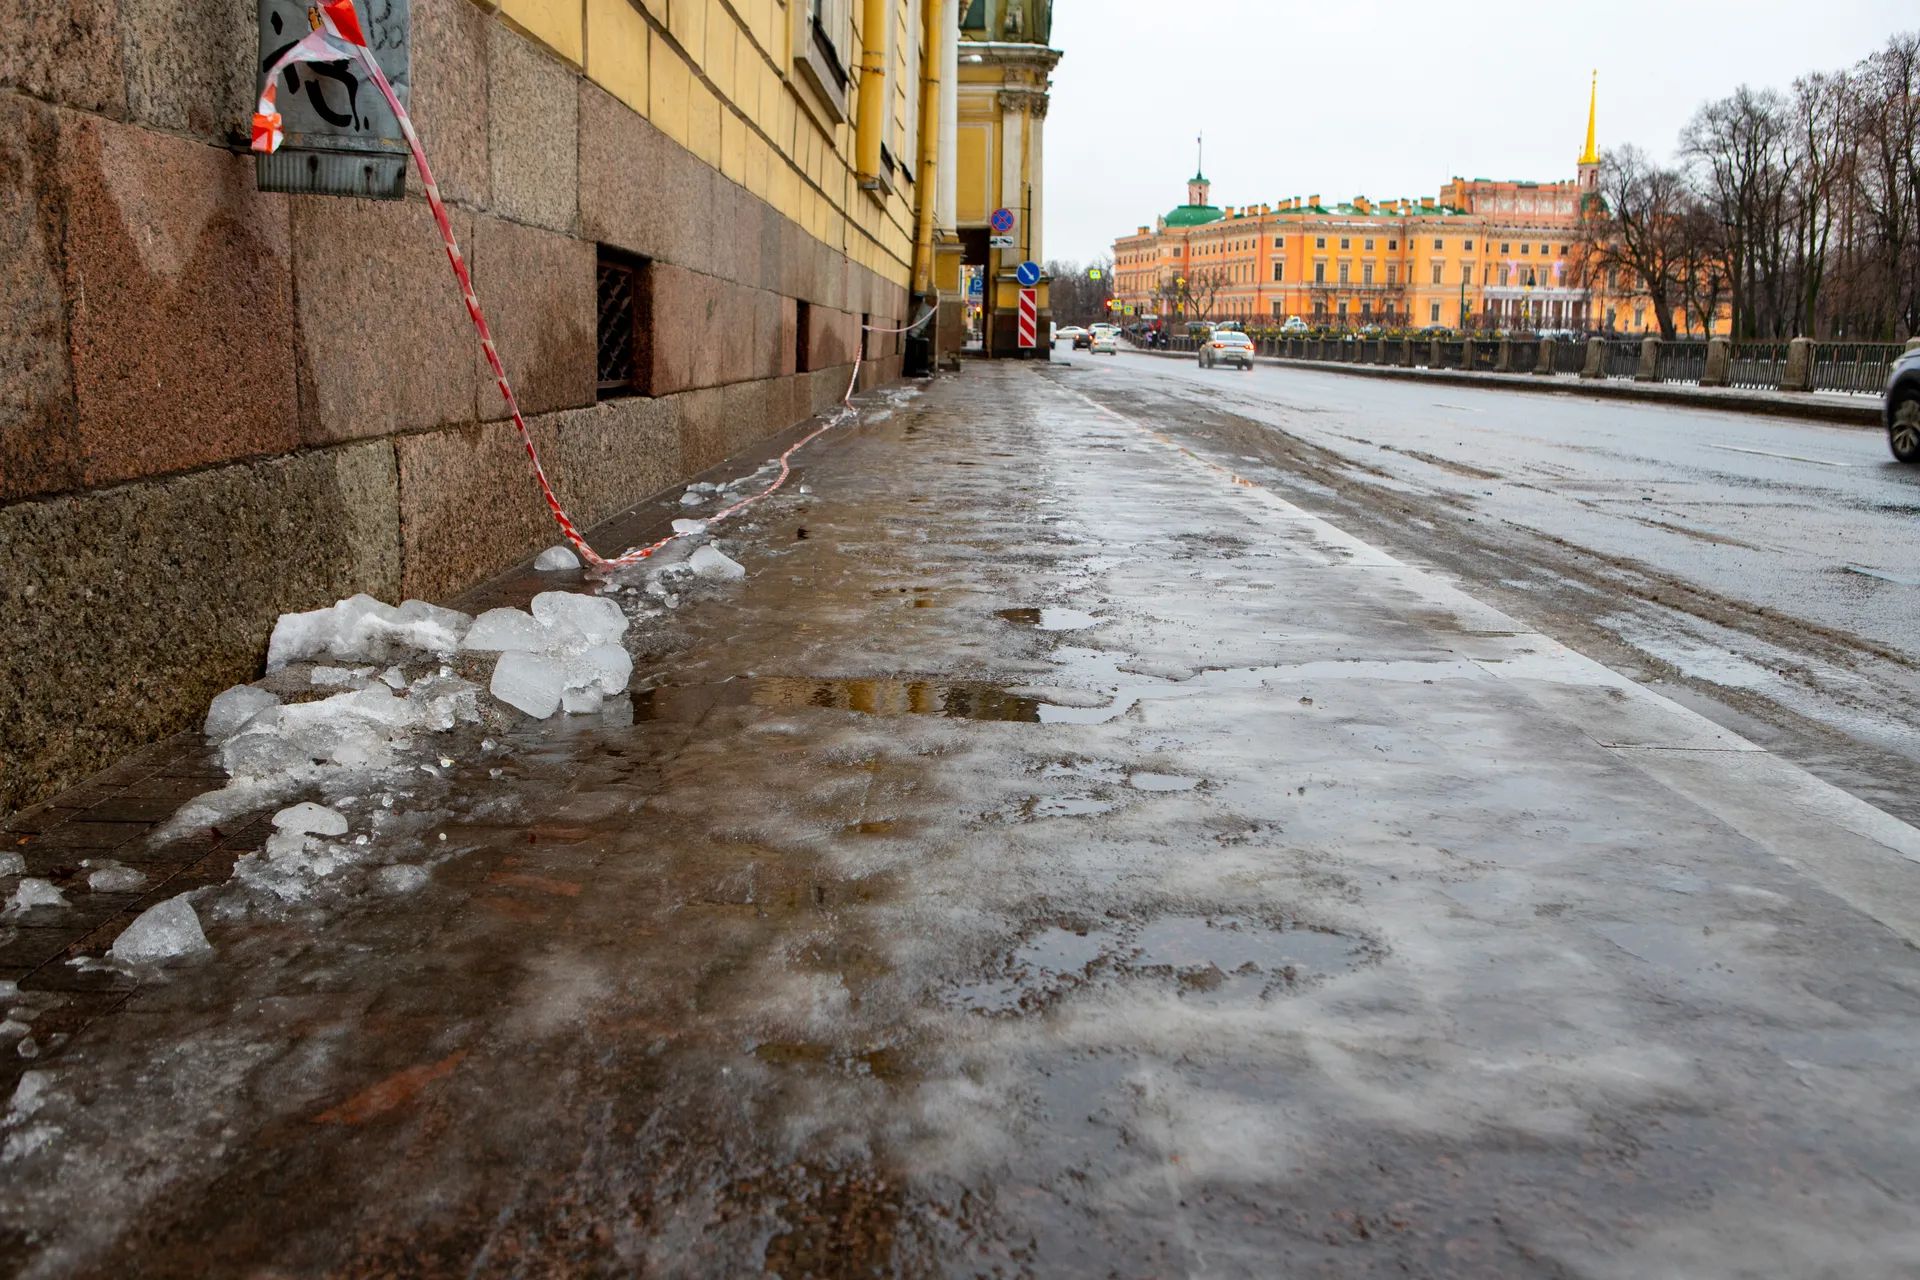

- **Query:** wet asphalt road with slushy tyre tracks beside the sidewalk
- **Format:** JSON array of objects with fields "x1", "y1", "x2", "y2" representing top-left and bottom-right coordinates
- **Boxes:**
[{"x1": 1062, "y1": 347, "x2": 1920, "y2": 821}]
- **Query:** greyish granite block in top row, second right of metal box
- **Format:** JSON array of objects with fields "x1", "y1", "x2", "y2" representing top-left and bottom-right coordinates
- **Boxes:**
[{"x1": 488, "y1": 23, "x2": 580, "y2": 232}]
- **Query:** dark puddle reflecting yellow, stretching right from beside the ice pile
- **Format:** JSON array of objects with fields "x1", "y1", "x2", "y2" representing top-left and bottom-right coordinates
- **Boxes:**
[{"x1": 634, "y1": 676, "x2": 1044, "y2": 723}]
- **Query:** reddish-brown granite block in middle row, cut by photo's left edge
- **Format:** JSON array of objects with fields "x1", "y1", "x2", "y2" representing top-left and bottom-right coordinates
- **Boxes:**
[{"x1": 0, "y1": 94, "x2": 81, "y2": 501}]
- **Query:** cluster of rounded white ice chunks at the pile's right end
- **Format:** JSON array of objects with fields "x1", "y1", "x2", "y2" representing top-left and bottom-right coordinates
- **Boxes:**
[{"x1": 463, "y1": 591, "x2": 634, "y2": 720}]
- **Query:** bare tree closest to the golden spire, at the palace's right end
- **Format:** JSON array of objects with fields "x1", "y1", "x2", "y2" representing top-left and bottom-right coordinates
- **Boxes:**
[{"x1": 1582, "y1": 146, "x2": 1693, "y2": 338}]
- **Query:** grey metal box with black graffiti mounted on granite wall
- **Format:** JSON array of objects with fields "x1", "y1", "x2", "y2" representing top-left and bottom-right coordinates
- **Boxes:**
[{"x1": 253, "y1": 0, "x2": 413, "y2": 200}]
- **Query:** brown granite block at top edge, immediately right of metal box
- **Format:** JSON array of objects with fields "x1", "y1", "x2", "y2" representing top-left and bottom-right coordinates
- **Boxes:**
[{"x1": 407, "y1": 0, "x2": 493, "y2": 205}]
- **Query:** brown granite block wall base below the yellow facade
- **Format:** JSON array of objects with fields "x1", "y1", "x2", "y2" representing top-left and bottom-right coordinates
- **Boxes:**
[{"x1": 0, "y1": 0, "x2": 908, "y2": 814}]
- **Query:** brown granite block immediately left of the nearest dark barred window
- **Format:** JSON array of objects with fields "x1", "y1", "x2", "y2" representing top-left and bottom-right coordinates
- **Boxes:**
[{"x1": 468, "y1": 215, "x2": 597, "y2": 418}]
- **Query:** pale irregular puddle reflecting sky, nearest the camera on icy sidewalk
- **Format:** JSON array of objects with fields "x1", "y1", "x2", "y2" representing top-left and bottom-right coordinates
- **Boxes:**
[{"x1": 943, "y1": 913, "x2": 1379, "y2": 1015}]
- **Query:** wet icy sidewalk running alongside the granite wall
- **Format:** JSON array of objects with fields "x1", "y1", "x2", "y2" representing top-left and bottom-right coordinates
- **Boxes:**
[{"x1": 11, "y1": 365, "x2": 1920, "y2": 1280}]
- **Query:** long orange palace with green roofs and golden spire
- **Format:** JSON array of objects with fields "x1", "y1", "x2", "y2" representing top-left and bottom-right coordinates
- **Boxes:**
[{"x1": 1114, "y1": 84, "x2": 1640, "y2": 330}]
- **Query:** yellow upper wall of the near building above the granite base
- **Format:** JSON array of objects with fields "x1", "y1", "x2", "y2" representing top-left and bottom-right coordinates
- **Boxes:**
[{"x1": 499, "y1": 0, "x2": 927, "y2": 286}]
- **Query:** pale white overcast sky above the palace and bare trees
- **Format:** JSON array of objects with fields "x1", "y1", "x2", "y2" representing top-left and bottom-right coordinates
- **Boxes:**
[{"x1": 1044, "y1": 0, "x2": 1920, "y2": 261}]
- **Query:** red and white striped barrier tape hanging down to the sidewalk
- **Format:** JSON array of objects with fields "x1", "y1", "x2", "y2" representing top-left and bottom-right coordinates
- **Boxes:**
[{"x1": 252, "y1": 0, "x2": 933, "y2": 572}]
